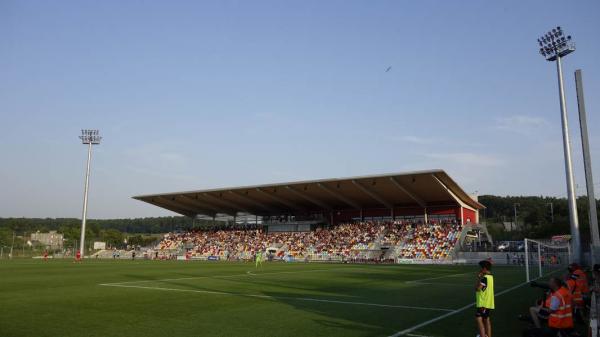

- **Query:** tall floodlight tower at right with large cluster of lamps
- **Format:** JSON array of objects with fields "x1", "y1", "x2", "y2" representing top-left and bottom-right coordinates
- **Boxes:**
[{"x1": 538, "y1": 27, "x2": 581, "y2": 262}]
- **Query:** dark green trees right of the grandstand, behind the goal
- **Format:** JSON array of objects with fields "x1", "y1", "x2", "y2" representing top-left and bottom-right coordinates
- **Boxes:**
[{"x1": 479, "y1": 195, "x2": 600, "y2": 244}]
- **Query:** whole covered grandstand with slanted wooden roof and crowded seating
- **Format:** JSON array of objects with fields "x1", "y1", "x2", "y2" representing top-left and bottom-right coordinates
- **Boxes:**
[{"x1": 134, "y1": 170, "x2": 487, "y2": 262}]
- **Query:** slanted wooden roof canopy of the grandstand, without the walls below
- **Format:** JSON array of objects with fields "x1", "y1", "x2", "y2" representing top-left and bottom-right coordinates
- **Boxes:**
[{"x1": 133, "y1": 170, "x2": 484, "y2": 217}]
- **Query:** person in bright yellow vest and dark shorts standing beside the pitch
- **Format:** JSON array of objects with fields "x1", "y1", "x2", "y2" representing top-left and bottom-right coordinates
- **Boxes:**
[{"x1": 475, "y1": 260, "x2": 495, "y2": 337}]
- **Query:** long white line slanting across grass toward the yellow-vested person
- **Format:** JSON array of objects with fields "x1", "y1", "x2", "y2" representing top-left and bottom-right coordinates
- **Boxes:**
[{"x1": 100, "y1": 284, "x2": 452, "y2": 312}]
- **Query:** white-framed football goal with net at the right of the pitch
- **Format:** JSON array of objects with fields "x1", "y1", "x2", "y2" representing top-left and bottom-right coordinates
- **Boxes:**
[{"x1": 524, "y1": 239, "x2": 571, "y2": 282}]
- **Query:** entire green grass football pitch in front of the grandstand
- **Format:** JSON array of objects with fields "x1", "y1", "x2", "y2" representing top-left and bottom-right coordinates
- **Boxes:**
[{"x1": 0, "y1": 260, "x2": 540, "y2": 337}]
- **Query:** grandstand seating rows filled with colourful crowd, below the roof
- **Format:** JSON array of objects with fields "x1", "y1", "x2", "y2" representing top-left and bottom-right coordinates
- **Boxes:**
[{"x1": 155, "y1": 221, "x2": 462, "y2": 261}]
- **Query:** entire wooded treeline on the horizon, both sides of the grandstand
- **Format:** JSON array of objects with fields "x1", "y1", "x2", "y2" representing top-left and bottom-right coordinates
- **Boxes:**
[{"x1": 0, "y1": 195, "x2": 599, "y2": 246}]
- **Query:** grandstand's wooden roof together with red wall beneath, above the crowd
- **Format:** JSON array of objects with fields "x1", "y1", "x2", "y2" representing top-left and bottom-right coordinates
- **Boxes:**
[{"x1": 133, "y1": 170, "x2": 483, "y2": 225}]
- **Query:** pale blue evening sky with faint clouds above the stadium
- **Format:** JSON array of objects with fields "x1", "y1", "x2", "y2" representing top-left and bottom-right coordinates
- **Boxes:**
[{"x1": 0, "y1": 0, "x2": 600, "y2": 218}]
